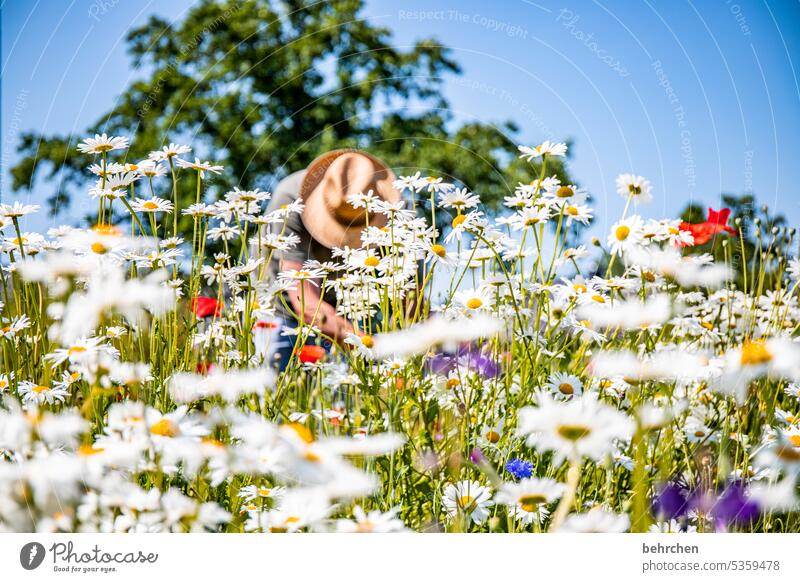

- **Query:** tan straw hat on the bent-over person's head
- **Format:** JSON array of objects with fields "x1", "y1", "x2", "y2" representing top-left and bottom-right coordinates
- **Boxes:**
[{"x1": 300, "y1": 149, "x2": 400, "y2": 248}]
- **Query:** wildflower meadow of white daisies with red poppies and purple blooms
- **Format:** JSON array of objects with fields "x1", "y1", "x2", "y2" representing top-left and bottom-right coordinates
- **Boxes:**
[{"x1": 0, "y1": 135, "x2": 800, "y2": 532}]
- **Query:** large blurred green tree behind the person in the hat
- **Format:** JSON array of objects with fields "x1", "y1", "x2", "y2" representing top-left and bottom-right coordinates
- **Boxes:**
[{"x1": 12, "y1": 0, "x2": 566, "y2": 232}]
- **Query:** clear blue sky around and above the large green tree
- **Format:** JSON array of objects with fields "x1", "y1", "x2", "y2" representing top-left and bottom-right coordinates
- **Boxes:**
[{"x1": 0, "y1": 0, "x2": 800, "y2": 237}]
